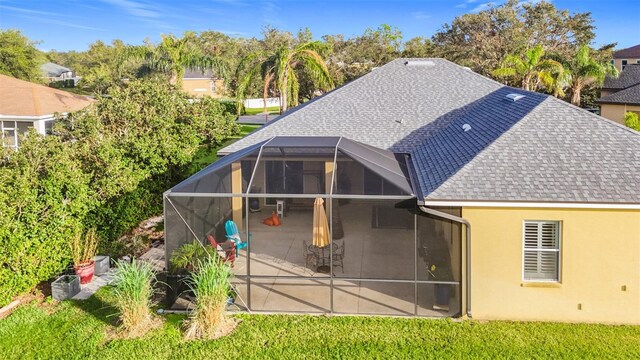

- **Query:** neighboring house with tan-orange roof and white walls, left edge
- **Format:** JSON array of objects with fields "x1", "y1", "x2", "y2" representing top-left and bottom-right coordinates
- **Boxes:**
[{"x1": 0, "y1": 75, "x2": 93, "y2": 148}]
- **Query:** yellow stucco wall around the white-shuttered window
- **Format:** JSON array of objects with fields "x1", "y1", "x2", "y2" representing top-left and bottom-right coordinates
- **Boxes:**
[{"x1": 462, "y1": 208, "x2": 640, "y2": 324}]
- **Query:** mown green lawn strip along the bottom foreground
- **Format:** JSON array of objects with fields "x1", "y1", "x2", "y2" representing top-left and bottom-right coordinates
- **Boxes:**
[{"x1": 0, "y1": 289, "x2": 640, "y2": 360}]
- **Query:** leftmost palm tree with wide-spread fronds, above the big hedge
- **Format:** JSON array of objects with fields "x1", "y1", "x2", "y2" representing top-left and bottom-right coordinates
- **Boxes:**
[{"x1": 119, "y1": 34, "x2": 226, "y2": 86}]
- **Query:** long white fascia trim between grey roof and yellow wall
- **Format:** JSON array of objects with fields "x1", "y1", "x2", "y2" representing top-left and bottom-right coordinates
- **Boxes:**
[{"x1": 424, "y1": 200, "x2": 640, "y2": 210}]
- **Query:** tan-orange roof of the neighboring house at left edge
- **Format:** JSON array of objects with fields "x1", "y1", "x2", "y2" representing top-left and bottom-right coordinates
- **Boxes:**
[{"x1": 0, "y1": 75, "x2": 93, "y2": 117}]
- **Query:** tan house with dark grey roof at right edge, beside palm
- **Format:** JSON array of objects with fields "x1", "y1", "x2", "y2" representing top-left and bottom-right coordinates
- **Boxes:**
[{"x1": 596, "y1": 64, "x2": 640, "y2": 124}]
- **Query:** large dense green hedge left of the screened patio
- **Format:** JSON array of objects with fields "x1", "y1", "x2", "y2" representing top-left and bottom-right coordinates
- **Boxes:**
[{"x1": 0, "y1": 81, "x2": 239, "y2": 306}]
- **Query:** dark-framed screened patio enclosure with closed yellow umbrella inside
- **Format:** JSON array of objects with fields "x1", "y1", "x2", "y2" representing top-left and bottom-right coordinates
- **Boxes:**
[{"x1": 164, "y1": 137, "x2": 462, "y2": 316}]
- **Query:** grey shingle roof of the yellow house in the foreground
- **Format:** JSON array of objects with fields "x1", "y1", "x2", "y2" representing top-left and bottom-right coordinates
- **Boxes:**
[{"x1": 220, "y1": 59, "x2": 640, "y2": 204}]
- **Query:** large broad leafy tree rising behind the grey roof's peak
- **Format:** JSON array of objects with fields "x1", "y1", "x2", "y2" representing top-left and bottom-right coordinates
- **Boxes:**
[{"x1": 432, "y1": 0, "x2": 595, "y2": 75}]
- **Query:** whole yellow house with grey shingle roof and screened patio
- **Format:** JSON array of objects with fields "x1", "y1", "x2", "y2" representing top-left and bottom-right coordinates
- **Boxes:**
[{"x1": 164, "y1": 59, "x2": 640, "y2": 324}]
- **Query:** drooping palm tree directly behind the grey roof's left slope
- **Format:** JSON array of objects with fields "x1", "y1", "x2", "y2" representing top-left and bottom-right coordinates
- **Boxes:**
[{"x1": 236, "y1": 41, "x2": 333, "y2": 113}]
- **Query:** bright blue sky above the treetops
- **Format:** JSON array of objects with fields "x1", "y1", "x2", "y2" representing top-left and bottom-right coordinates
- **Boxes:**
[{"x1": 0, "y1": 0, "x2": 640, "y2": 51}]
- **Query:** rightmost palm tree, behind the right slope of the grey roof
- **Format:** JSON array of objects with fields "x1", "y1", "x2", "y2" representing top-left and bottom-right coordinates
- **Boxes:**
[{"x1": 562, "y1": 45, "x2": 618, "y2": 106}]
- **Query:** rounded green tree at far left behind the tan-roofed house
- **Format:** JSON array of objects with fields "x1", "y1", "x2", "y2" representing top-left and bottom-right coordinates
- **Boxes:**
[{"x1": 0, "y1": 29, "x2": 45, "y2": 82}]
